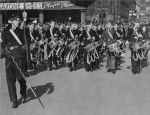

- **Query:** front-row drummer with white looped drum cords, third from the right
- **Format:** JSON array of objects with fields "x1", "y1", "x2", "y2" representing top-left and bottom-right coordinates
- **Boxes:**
[{"x1": 84, "y1": 24, "x2": 99, "y2": 71}]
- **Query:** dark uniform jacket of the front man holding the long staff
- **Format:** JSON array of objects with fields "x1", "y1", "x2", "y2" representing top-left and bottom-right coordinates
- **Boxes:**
[{"x1": 1, "y1": 28, "x2": 26, "y2": 58}]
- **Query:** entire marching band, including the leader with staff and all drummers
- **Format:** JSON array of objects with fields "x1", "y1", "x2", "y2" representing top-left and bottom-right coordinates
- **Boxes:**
[{"x1": 0, "y1": 13, "x2": 150, "y2": 108}]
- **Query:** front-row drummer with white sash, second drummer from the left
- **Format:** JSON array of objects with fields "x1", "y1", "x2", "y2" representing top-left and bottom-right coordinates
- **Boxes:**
[{"x1": 47, "y1": 21, "x2": 58, "y2": 70}]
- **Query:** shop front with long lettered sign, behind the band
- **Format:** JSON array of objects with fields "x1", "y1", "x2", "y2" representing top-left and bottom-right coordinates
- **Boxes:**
[{"x1": 0, "y1": 1, "x2": 86, "y2": 25}]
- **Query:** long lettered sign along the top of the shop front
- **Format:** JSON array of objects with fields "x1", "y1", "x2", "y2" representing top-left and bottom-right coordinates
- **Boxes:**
[{"x1": 0, "y1": 1, "x2": 74, "y2": 10}]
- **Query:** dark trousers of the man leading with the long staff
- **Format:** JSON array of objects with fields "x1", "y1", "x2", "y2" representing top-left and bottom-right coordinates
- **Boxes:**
[{"x1": 5, "y1": 58, "x2": 27, "y2": 102}]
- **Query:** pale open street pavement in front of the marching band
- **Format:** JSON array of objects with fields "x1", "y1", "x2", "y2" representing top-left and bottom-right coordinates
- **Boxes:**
[{"x1": 0, "y1": 51, "x2": 150, "y2": 115}]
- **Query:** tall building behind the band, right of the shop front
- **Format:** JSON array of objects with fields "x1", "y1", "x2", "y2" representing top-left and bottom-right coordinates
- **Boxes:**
[{"x1": 86, "y1": 0, "x2": 136, "y2": 20}]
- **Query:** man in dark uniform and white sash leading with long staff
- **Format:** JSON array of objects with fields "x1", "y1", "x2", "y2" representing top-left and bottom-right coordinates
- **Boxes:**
[{"x1": 1, "y1": 15, "x2": 27, "y2": 108}]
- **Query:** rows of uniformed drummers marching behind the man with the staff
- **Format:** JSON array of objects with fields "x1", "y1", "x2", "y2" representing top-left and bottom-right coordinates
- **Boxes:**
[{"x1": 3, "y1": 18, "x2": 150, "y2": 74}]
